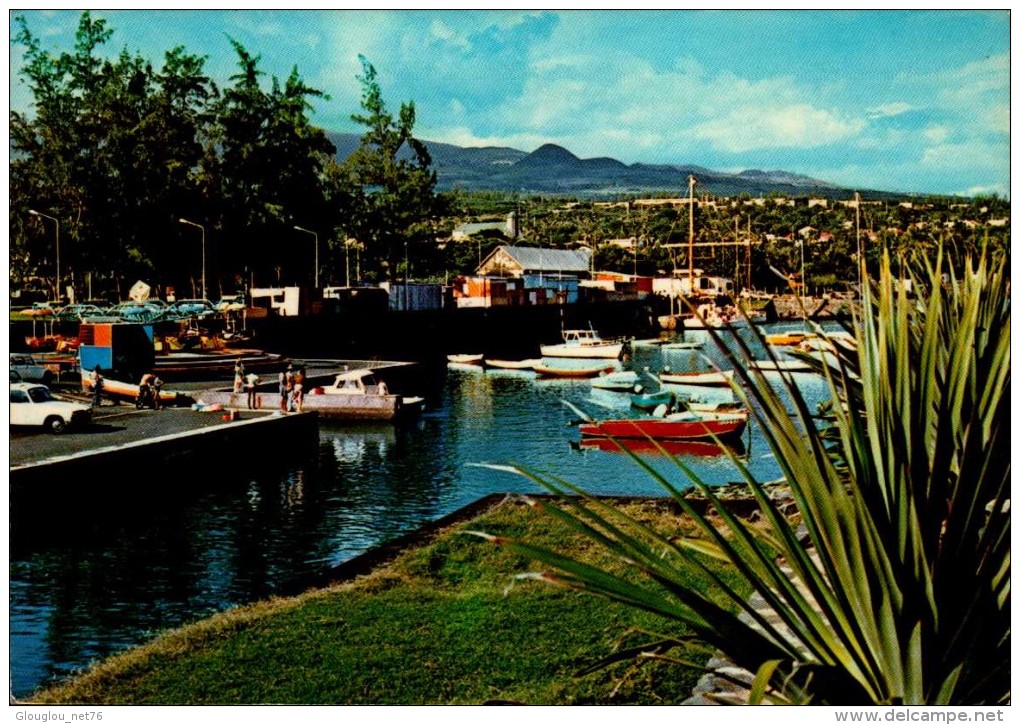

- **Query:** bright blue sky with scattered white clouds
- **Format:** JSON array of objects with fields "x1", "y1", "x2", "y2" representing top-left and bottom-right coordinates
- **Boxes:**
[{"x1": 10, "y1": 10, "x2": 1010, "y2": 196}]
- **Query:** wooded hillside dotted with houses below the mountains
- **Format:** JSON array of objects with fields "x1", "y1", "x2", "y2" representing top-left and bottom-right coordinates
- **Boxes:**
[{"x1": 448, "y1": 192, "x2": 1010, "y2": 292}]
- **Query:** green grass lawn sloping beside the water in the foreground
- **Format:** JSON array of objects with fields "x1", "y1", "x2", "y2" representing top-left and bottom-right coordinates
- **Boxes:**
[{"x1": 33, "y1": 504, "x2": 750, "y2": 705}]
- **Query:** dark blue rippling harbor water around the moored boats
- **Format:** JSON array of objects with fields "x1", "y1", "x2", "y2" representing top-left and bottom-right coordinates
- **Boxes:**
[{"x1": 9, "y1": 324, "x2": 844, "y2": 696}]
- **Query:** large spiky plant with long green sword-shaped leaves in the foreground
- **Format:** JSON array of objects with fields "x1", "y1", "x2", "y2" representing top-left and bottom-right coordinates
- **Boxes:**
[{"x1": 471, "y1": 253, "x2": 1011, "y2": 705}]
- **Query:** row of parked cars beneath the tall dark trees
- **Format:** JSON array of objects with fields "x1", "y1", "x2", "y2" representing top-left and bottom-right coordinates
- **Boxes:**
[{"x1": 24, "y1": 295, "x2": 246, "y2": 322}]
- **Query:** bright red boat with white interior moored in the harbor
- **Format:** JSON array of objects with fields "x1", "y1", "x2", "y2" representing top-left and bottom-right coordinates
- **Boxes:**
[{"x1": 580, "y1": 411, "x2": 748, "y2": 441}]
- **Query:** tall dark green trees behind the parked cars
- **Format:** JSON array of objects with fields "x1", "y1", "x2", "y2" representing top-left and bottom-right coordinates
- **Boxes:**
[{"x1": 10, "y1": 11, "x2": 439, "y2": 297}]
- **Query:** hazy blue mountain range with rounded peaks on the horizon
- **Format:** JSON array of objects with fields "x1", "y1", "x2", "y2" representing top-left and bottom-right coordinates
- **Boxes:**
[{"x1": 329, "y1": 134, "x2": 877, "y2": 198}]
